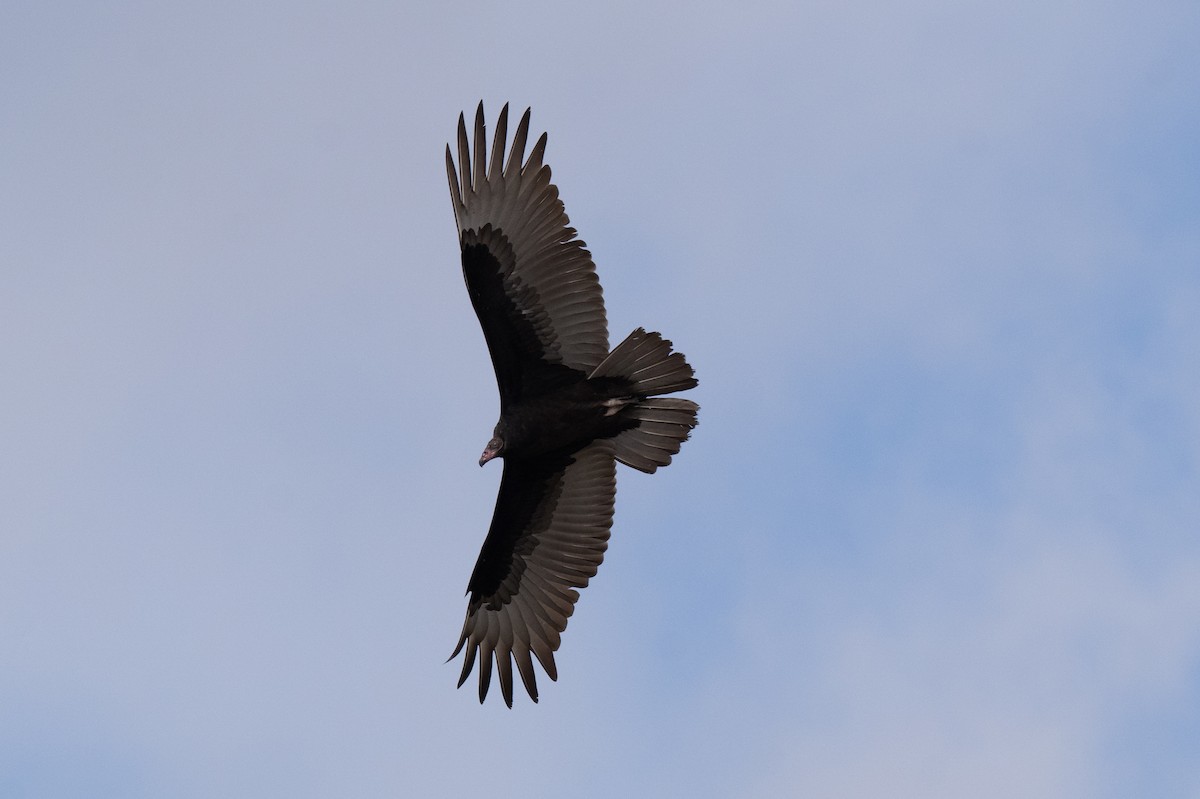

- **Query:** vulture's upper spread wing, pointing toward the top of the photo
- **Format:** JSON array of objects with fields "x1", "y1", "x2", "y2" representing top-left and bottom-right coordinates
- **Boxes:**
[{"x1": 446, "y1": 103, "x2": 608, "y2": 411}]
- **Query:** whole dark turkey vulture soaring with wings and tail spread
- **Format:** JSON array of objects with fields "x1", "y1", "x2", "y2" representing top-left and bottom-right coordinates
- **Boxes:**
[{"x1": 446, "y1": 103, "x2": 700, "y2": 708}]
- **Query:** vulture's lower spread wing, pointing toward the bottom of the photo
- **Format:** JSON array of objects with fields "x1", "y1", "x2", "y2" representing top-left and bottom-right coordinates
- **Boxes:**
[{"x1": 450, "y1": 439, "x2": 617, "y2": 707}]
